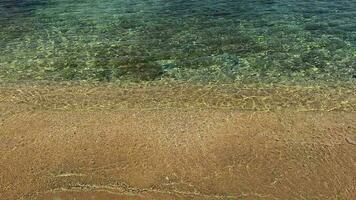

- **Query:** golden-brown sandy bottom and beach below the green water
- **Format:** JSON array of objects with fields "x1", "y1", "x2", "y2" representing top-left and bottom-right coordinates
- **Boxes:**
[{"x1": 0, "y1": 83, "x2": 356, "y2": 200}]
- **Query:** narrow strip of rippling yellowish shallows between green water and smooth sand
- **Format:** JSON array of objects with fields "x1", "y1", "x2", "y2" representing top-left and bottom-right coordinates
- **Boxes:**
[{"x1": 0, "y1": 83, "x2": 356, "y2": 112}]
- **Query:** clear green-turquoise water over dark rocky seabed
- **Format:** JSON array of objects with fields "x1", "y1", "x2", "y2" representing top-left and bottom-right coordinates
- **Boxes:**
[{"x1": 0, "y1": 0, "x2": 356, "y2": 82}]
